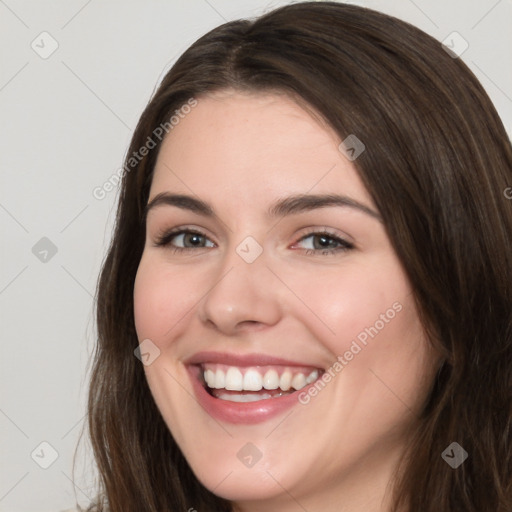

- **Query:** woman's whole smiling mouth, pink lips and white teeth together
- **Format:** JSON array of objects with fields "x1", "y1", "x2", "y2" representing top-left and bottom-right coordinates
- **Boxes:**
[{"x1": 186, "y1": 352, "x2": 324, "y2": 424}]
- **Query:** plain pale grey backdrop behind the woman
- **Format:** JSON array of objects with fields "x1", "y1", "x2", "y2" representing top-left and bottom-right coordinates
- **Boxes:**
[{"x1": 0, "y1": 0, "x2": 512, "y2": 512}]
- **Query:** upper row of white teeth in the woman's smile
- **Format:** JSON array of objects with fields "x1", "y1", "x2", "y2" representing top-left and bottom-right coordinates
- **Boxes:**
[{"x1": 203, "y1": 366, "x2": 318, "y2": 391}]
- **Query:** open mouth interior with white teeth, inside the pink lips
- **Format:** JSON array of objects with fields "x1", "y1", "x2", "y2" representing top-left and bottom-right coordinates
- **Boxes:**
[{"x1": 199, "y1": 363, "x2": 323, "y2": 403}]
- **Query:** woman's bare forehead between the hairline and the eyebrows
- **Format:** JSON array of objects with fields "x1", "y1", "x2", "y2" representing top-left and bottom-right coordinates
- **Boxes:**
[{"x1": 150, "y1": 91, "x2": 372, "y2": 208}]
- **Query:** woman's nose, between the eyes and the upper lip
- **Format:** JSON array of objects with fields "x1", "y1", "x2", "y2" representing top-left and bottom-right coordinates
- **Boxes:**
[{"x1": 198, "y1": 244, "x2": 282, "y2": 335}]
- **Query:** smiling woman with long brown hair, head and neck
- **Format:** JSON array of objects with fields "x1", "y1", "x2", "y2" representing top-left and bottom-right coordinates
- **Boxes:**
[{"x1": 82, "y1": 2, "x2": 512, "y2": 512}]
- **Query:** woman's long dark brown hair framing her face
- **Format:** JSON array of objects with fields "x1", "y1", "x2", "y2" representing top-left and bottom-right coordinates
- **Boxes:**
[{"x1": 82, "y1": 2, "x2": 512, "y2": 512}]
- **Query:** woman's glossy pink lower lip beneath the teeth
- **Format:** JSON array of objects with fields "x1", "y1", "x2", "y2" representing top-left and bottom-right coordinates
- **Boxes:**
[{"x1": 188, "y1": 366, "x2": 314, "y2": 424}]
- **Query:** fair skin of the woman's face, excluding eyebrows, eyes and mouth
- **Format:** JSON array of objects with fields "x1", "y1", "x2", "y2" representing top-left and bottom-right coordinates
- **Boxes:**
[{"x1": 134, "y1": 91, "x2": 435, "y2": 512}]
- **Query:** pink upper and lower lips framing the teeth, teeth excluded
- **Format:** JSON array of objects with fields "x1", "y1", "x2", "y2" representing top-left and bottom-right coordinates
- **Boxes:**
[{"x1": 185, "y1": 352, "x2": 321, "y2": 424}]
